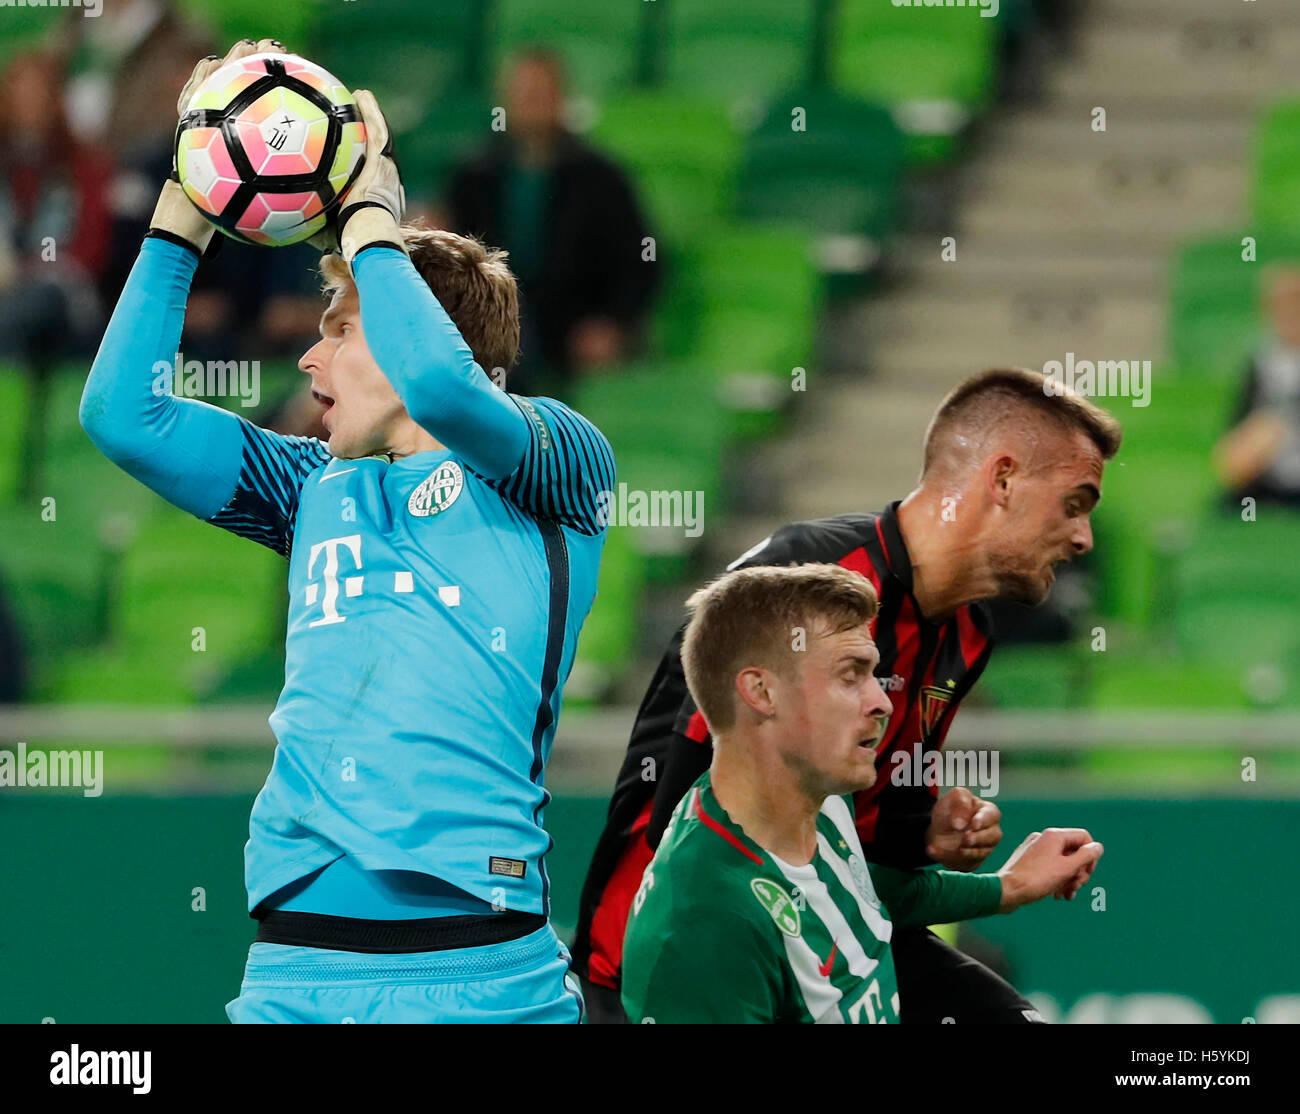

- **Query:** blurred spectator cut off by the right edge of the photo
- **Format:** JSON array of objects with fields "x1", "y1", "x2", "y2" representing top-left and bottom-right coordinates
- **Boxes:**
[{"x1": 1214, "y1": 269, "x2": 1300, "y2": 507}]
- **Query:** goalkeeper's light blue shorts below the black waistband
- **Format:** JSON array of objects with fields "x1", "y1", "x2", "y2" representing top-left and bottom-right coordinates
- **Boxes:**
[{"x1": 226, "y1": 924, "x2": 582, "y2": 1024}]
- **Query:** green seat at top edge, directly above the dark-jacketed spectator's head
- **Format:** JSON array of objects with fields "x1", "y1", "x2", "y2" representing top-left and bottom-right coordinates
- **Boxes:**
[{"x1": 494, "y1": 0, "x2": 651, "y2": 99}]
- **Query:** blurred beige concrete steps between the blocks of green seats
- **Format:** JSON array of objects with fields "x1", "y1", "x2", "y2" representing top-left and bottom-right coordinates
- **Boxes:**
[{"x1": 776, "y1": 1, "x2": 1274, "y2": 517}]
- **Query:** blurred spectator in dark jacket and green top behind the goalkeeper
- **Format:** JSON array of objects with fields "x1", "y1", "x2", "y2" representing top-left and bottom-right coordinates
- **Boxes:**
[{"x1": 445, "y1": 48, "x2": 657, "y2": 398}]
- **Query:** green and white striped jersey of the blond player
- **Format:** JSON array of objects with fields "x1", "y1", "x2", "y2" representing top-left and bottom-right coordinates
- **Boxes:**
[{"x1": 623, "y1": 773, "x2": 1002, "y2": 1023}]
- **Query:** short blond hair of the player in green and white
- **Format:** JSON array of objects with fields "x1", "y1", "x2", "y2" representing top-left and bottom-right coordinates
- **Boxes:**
[{"x1": 681, "y1": 564, "x2": 880, "y2": 733}]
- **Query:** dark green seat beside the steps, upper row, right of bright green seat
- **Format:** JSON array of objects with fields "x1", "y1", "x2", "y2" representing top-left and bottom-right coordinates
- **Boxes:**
[{"x1": 736, "y1": 90, "x2": 904, "y2": 270}]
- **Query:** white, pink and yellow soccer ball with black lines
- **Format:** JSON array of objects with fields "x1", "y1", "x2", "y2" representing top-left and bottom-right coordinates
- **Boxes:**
[{"x1": 176, "y1": 55, "x2": 365, "y2": 247}]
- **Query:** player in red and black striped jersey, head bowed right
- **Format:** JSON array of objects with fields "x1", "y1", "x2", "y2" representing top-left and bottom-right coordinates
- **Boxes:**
[{"x1": 573, "y1": 369, "x2": 1121, "y2": 1023}]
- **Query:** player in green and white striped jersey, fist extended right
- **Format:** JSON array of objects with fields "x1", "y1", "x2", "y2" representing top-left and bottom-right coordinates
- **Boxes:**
[{"x1": 623, "y1": 564, "x2": 1101, "y2": 1023}]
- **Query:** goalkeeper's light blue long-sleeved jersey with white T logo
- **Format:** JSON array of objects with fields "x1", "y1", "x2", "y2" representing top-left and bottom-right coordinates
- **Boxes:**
[{"x1": 82, "y1": 239, "x2": 615, "y2": 914}]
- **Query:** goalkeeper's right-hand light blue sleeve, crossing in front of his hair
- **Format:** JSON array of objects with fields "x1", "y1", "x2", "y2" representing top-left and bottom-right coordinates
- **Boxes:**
[{"x1": 352, "y1": 247, "x2": 615, "y2": 536}]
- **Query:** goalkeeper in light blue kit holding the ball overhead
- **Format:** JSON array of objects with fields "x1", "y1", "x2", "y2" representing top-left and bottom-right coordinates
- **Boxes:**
[{"x1": 81, "y1": 40, "x2": 615, "y2": 1022}]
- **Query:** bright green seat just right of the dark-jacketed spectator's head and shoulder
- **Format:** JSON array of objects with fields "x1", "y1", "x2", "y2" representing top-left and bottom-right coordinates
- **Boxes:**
[{"x1": 590, "y1": 94, "x2": 740, "y2": 246}]
